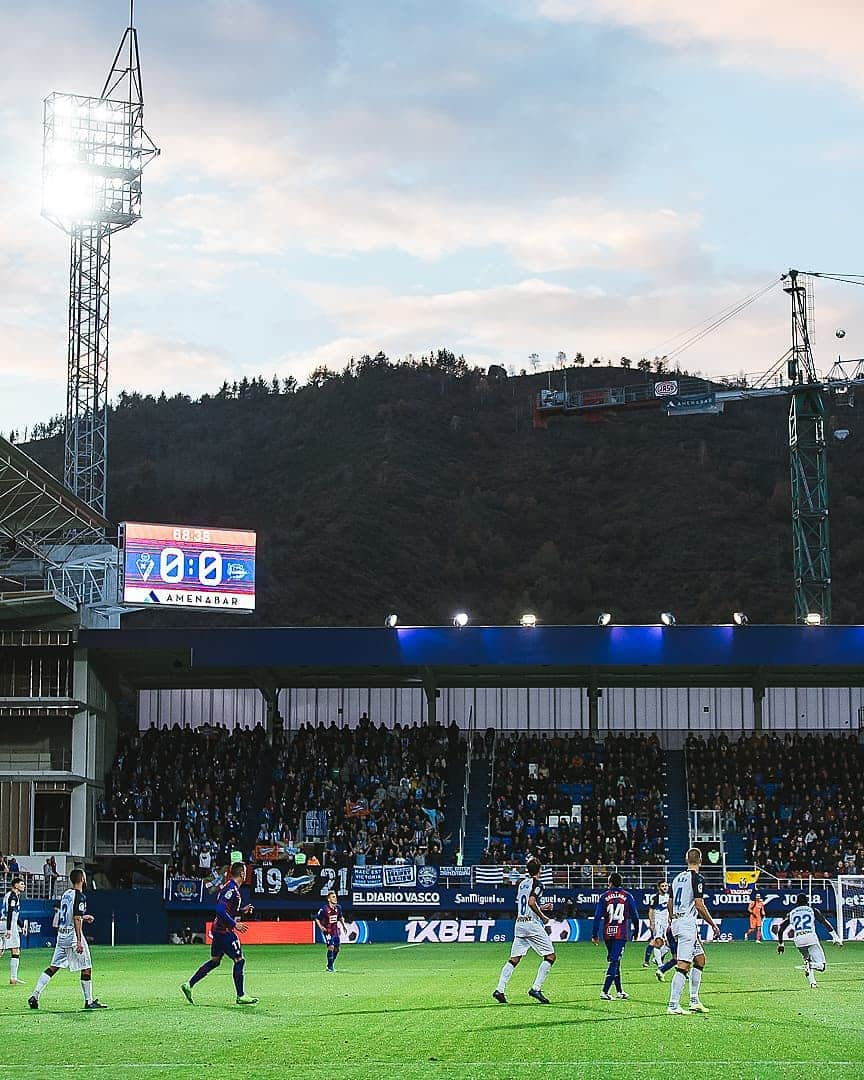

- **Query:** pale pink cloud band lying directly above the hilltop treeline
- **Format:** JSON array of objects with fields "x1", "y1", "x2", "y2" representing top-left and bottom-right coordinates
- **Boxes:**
[{"x1": 279, "y1": 276, "x2": 788, "y2": 378}]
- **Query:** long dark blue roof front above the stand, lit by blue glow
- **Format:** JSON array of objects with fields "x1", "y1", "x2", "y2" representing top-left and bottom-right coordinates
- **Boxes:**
[{"x1": 79, "y1": 626, "x2": 864, "y2": 690}]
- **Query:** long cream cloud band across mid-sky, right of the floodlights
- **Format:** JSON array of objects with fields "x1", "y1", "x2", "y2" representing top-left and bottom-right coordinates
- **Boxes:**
[{"x1": 168, "y1": 187, "x2": 704, "y2": 273}]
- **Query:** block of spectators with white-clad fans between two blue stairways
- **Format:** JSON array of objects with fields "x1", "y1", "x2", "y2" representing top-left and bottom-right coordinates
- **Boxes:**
[{"x1": 484, "y1": 732, "x2": 665, "y2": 865}]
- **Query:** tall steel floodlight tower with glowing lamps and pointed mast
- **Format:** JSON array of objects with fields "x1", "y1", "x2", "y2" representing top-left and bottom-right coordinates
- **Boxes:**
[{"x1": 42, "y1": 0, "x2": 159, "y2": 515}]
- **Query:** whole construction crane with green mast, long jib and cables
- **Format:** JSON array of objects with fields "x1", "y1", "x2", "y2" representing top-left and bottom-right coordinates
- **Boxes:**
[{"x1": 534, "y1": 270, "x2": 864, "y2": 625}]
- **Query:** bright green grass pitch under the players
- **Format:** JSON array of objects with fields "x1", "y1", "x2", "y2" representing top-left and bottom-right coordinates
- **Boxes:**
[{"x1": 0, "y1": 943, "x2": 864, "y2": 1080}]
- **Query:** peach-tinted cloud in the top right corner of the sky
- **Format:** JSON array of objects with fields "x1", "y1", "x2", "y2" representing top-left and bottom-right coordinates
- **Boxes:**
[{"x1": 535, "y1": 0, "x2": 864, "y2": 90}]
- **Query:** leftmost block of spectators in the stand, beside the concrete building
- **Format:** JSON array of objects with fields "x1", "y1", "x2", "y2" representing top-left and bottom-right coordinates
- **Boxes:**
[{"x1": 99, "y1": 725, "x2": 269, "y2": 874}]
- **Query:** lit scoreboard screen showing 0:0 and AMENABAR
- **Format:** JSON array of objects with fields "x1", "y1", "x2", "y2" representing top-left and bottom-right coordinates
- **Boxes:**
[{"x1": 120, "y1": 522, "x2": 255, "y2": 611}]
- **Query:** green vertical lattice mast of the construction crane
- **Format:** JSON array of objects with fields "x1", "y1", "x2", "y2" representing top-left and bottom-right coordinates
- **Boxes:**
[{"x1": 784, "y1": 270, "x2": 832, "y2": 622}]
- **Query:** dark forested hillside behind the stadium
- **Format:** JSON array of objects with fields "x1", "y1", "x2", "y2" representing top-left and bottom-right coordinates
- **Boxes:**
[{"x1": 18, "y1": 352, "x2": 864, "y2": 625}]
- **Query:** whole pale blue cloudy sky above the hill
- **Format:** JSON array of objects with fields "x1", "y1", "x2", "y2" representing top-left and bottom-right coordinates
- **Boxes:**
[{"x1": 0, "y1": 0, "x2": 864, "y2": 432}]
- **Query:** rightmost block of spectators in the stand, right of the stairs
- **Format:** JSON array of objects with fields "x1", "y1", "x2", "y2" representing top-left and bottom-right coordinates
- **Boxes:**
[{"x1": 687, "y1": 733, "x2": 864, "y2": 878}]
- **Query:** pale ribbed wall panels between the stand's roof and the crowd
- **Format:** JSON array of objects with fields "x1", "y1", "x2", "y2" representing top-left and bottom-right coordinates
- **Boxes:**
[{"x1": 138, "y1": 687, "x2": 864, "y2": 743}]
